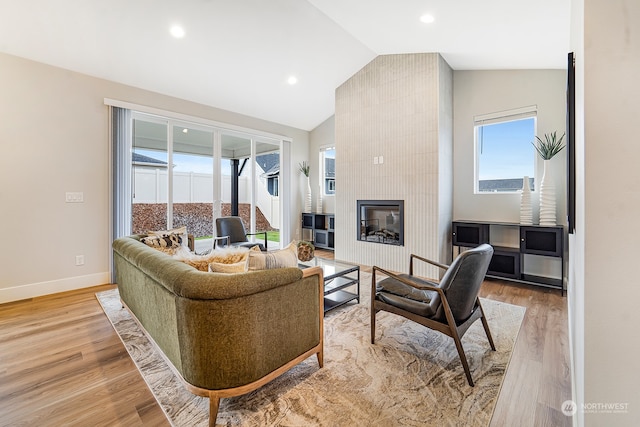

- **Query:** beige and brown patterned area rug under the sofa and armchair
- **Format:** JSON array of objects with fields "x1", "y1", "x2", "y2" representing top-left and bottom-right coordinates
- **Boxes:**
[{"x1": 96, "y1": 273, "x2": 525, "y2": 427}]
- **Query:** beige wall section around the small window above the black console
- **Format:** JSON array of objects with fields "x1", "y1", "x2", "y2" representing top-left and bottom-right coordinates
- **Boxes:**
[{"x1": 453, "y1": 70, "x2": 567, "y2": 225}]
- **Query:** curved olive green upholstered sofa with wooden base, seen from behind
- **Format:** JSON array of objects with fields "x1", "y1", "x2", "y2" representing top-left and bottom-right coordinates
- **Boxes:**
[{"x1": 113, "y1": 235, "x2": 323, "y2": 426}]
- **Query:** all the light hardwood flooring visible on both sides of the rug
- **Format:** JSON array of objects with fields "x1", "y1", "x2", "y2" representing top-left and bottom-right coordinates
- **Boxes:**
[{"x1": 0, "y1": 250, "x2": 571, "y2": 427}]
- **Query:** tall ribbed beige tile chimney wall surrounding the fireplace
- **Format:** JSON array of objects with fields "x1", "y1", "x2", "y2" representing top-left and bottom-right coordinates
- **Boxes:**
[{"x1": 335, "y1": 53, "x2": 453, "y2": 277}]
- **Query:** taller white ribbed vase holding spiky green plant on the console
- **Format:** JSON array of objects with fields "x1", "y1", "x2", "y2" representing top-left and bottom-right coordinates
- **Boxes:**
[{"x1": 532, "y1": 131, "x2": 565, "y2": 226}]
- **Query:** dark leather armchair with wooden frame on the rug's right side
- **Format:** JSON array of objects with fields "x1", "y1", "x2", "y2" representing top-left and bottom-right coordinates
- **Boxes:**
[{"x1": 371, "y1": 244, "x2": 496, "y2": 387}]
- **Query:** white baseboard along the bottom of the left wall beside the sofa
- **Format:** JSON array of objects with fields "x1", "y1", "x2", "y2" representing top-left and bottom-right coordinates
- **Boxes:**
[{"x1": 0, "y1": 271, "x2": 111, "y2": 304}]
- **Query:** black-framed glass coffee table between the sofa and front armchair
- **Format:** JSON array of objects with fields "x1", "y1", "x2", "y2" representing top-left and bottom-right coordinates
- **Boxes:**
[{"x1": 298, "y1": 257, "x2": 360, "y2": 313}]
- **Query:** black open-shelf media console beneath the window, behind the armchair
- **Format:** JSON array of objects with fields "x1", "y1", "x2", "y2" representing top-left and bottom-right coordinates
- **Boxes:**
[{"x1": 451, "y1": 221, "x2": 565, "y2": 296}]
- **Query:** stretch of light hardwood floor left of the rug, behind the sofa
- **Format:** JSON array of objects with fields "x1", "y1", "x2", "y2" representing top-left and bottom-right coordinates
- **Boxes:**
[{"x1": 0, "y1": 285, "x2": 169, "y2": 426}]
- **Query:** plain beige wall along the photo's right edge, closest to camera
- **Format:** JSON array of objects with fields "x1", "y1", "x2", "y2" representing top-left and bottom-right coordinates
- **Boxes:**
[{"x1": 575, "y1": 0, "x2": 640, "y2": 426}]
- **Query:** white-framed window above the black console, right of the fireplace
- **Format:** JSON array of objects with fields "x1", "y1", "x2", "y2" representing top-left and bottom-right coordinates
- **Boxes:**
[{"x1": 475, "y1": 107, "x2": 536, "y2": 194}]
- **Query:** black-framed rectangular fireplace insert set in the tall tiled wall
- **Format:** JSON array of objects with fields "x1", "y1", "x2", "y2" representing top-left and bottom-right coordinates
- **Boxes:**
[{"x1": 357, "y1": 200, "x2": 404, "y2": 246}]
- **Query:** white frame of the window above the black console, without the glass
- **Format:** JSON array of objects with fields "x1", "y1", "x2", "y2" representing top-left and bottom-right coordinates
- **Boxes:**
[{"x1": 473, "y1": 105, "x2": 540, "y2": 195}]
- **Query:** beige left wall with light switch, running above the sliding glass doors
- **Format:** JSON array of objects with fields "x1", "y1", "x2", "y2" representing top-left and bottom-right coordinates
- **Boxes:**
[{"x1": 0, "y1": 54, "x2": 309, "y2": 303}]
